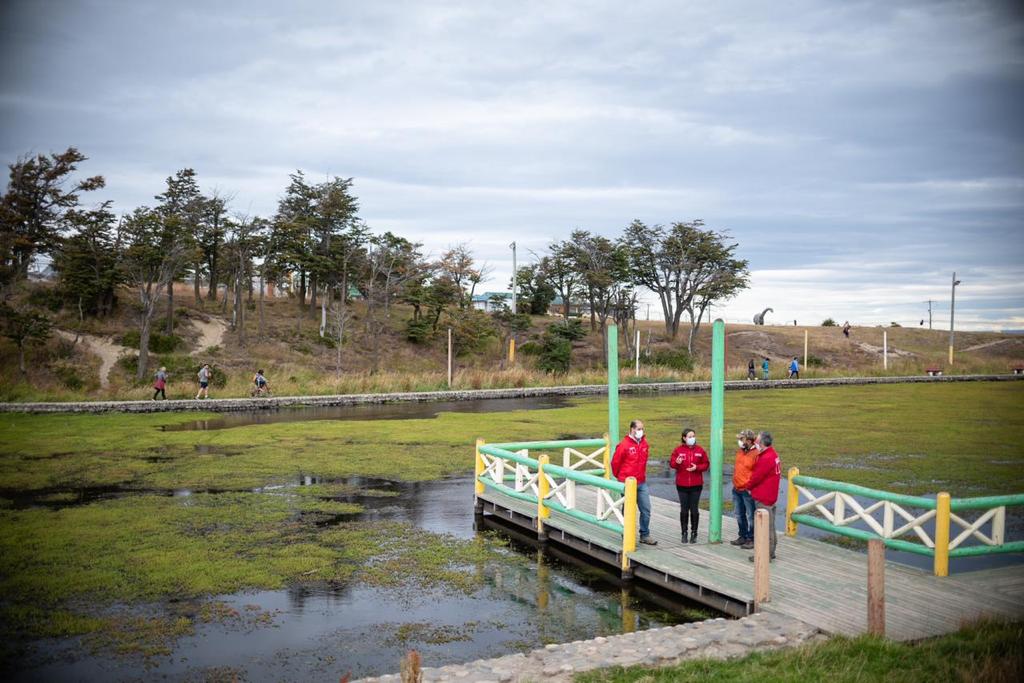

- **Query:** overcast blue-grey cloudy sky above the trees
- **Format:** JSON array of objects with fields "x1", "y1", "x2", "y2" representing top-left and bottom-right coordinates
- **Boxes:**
[{"x1": 0, "y1": 0, "x2": 1024, "y2": 330}]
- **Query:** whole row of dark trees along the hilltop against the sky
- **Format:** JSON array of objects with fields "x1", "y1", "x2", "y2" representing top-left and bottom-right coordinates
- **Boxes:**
[{"x1": 0, "y1": 147, "x2": 748, "y2": 379}]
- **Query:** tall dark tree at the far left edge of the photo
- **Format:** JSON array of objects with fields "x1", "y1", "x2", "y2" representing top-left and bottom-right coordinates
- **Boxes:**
[{"x1": 0, "y1": 147, "x2": 104, "y2": 287}]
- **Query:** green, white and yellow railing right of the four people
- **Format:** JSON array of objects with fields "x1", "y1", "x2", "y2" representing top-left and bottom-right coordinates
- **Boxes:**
[{"x1": 785, "y1": 467, "x2": 1024, "y2": 577}]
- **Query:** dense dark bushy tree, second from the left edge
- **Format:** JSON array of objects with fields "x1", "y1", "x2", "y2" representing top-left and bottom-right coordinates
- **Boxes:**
[{"x1": 53, "y1": 202, "x2": 124, "y2": 319}]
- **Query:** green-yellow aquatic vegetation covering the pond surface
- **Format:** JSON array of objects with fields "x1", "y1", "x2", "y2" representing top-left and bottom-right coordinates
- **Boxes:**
[{"x1": 0, "y1": 382, "x2": 1024, "y2": 667}]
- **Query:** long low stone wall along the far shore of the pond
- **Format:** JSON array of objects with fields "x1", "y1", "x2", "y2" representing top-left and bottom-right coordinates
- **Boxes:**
[{"x1": 0, "y1": 375, "x2": 1024, "y2": 413}]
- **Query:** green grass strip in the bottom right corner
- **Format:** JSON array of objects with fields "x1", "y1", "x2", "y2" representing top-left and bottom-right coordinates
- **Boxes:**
[{"x1": 573, "y1": 622, "x2": 1024, "y2": 683}]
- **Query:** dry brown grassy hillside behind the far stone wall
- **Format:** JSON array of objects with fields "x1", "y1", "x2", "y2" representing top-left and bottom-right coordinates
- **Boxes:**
[{"x1": 0, "y1": 285, "x2": 1024, "y2": 400}]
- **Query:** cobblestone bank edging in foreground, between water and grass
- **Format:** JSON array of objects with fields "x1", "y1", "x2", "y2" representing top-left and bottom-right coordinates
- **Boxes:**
[{"x1": 362, "y1": 612, "x2": 825, "y2": 683}]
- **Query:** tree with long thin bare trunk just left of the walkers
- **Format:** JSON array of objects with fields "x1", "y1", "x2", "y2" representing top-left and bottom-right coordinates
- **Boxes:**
[{"x1": 118, "y1": 207, "x2": 194, "y2": 380}]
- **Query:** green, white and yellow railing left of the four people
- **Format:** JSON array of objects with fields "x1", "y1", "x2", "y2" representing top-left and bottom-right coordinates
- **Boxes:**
[{"x1": 476, "y1": 436, "x2": 637, "y2": 569}]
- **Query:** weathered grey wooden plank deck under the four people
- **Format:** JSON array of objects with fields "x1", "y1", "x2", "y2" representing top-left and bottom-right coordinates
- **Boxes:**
[{"x1": 479, "y1": 486, "x2": 1024, "y2": 640}]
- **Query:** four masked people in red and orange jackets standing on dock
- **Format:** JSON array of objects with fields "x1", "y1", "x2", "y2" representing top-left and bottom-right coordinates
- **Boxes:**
[{"x1": 611, "y1": 420, "x2": 782, "y2": 561}]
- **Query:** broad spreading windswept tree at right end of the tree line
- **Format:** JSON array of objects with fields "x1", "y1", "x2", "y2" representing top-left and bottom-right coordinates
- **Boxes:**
[{"x1": 623, "y1": 219, "x2": 746, "y2": 351}]
